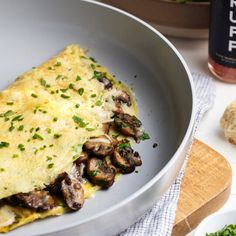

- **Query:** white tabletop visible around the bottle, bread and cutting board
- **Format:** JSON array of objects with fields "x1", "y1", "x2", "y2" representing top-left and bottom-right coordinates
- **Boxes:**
[{"x1": 169, "y1": 38, "x2": 236, "y2": 236}]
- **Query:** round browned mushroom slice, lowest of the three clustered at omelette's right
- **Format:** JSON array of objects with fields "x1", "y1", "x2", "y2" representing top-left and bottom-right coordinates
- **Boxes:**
[{"x1": 86, "y1": 157, "x2": 116, "y2": 188}]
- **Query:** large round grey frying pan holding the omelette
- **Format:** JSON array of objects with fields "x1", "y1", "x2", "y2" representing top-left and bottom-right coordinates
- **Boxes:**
[{"x1": 0, "y1": 0, "x2": 194, "y2": 236}]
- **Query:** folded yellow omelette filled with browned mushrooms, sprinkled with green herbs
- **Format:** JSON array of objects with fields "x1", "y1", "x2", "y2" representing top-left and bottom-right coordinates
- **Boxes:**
[{"x1": 0, "y1": 45, "x2": 149, "y2": 232}]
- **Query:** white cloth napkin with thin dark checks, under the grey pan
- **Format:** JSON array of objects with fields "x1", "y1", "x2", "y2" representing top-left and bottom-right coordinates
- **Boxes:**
[{"x1": 120, "y1": 73, "x2": 215, "y2": 236}]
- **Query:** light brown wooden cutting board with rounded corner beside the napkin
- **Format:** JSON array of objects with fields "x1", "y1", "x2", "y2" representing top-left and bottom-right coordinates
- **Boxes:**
[{"x1": 172, "y1": 140, "x2": 232, "y2": 236}]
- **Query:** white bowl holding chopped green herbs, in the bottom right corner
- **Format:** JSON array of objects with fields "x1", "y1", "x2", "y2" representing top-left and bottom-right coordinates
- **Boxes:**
[{"x1": 194, "y1": 210, "x2": 236, "y2": 236}]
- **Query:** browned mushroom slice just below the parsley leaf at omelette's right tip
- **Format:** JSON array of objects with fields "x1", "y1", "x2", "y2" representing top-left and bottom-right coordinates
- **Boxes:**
[{"x1": 112, "y1": 142, "x2": 142, "y2": 174}]
